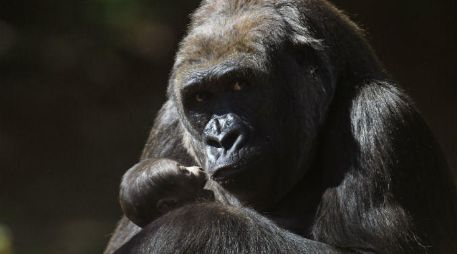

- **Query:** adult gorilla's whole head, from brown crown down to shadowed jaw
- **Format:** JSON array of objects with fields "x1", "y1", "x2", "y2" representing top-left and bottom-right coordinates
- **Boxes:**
[{"x1": 169, "y1": 3, "x2": 332, "y2": 207}]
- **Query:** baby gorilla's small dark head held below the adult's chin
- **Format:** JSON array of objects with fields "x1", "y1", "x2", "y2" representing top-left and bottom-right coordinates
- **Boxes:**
[{"x1": 119, "y1": 159, "x2": 214, "y2": 227}]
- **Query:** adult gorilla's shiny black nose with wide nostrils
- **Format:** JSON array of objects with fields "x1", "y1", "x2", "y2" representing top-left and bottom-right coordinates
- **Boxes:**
[{"x1": 204, "y1": 113, "x2": 247, "y2": 153}]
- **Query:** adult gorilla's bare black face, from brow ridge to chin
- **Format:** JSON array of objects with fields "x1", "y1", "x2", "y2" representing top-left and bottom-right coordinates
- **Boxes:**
[{"x1": 173, "y1": 60, "x2": 285, "y2": 206}]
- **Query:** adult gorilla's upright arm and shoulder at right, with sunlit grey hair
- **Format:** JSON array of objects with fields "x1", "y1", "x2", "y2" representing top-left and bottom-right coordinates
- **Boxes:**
[{"x1": 312, "y1": 80, "x2": 457, "y2": 253}]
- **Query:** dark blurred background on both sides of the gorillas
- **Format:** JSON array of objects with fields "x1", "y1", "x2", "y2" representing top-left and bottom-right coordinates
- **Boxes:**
[{"x1": 0, "y1": 0, "x2": 457, "y2": 254}]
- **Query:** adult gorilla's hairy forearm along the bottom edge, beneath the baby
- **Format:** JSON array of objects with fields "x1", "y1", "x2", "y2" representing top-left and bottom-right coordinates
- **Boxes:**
[{"x1": 115, "y1": 203, "x2": 345, "y2": 254}]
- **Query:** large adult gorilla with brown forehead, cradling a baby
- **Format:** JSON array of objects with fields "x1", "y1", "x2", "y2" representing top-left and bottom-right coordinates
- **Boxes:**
[{"x1": 106, "y1": 0, "x2": 457, "y2": 253}]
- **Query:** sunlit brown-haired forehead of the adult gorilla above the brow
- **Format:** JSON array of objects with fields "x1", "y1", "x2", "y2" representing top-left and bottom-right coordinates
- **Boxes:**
[{"x1": 175, "y1": 7, "x2": 281, "y2": 82}]
